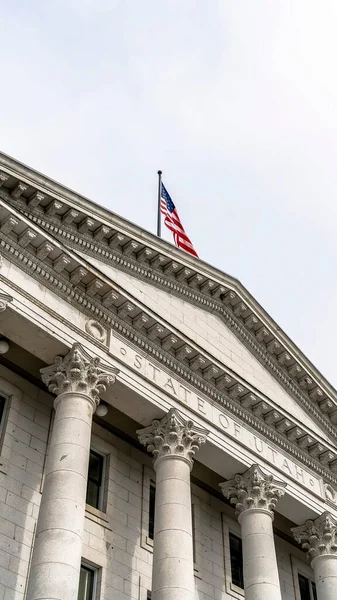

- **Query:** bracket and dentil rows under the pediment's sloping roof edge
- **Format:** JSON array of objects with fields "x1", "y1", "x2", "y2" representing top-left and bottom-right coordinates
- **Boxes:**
[{"x1": 0, "y1": 190, "x2": 337, "y2": 435}]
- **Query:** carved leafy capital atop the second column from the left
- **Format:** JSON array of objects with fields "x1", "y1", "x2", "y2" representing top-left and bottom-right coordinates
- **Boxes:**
[{"x1": 137, "y1": 408, "x2": 209, "y2": 468}]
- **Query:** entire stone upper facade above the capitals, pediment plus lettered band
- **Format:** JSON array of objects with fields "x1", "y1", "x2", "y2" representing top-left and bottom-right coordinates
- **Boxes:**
[{"x1": 0, "y1": 149, "x2": 337, "y2": 524}]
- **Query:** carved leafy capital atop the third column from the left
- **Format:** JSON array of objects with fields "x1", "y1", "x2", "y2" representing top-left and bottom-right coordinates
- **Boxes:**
[{"x1": 220, "y1": 465, "x2": 287, "y2": 515}]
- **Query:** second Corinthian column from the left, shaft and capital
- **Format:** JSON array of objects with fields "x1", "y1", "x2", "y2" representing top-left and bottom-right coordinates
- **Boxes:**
[{"x1": 137, "y1": 409, "x2": 208, "y2": 600}]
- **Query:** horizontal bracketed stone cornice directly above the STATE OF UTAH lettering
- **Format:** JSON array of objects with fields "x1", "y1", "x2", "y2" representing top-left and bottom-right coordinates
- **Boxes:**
[{"x1": 0, "y1": 202, "x2": 337, "y2": 485}]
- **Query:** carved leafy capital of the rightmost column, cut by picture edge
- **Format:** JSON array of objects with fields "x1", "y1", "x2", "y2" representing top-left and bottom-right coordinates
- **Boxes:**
[{"x1": 291, "y1": 512, "x2": 337, "y2": 560}]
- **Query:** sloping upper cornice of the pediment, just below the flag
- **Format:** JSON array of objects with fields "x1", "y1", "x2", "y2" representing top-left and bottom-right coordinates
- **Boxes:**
[{"x1": 0, "y1": 164, "x2": 337, "y2": 433}]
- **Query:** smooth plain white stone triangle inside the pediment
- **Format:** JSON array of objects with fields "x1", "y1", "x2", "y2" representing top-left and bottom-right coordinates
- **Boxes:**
[{"x1": 74, "y1": 253, "x2": 329, "y2": 441}]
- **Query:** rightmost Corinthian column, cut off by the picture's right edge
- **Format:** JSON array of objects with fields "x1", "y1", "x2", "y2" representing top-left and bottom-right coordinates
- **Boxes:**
[{"x1": 291, "y1": 512, "x2": 337, "y2": 600}]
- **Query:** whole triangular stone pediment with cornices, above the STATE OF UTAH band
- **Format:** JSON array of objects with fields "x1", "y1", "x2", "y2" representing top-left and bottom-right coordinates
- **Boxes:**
[{"x1": 0, "y1": 155, "x2": 337, "y2": 486}]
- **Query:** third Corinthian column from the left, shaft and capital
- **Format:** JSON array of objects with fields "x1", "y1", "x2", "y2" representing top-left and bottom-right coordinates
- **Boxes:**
[{"x1": 220, "y1": 465, "x2": 286, "y2": 600}]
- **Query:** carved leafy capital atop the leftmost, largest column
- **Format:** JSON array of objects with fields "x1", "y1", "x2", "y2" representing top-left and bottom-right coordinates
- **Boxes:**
[{"x1": 40, "y1": 343, "x2": 119, "y2": 405}]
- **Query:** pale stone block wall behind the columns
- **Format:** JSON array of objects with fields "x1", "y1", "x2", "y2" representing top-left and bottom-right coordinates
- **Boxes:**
[{"x1": 0, "y1": 367, "x2": 312, "y2": 600}]
